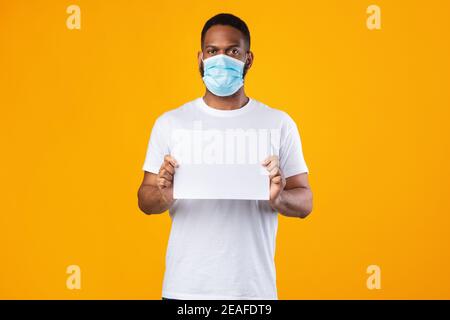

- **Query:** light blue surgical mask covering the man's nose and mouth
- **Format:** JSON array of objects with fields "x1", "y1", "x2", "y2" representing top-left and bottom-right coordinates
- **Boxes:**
[{"x1": 202, "y1": 54, "x2": 245, "y2": 97}]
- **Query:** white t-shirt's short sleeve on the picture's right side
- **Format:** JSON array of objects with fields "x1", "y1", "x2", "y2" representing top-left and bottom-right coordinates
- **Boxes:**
[{"x1": 280, "y1": 116, "x2": 309, "y2": 178}]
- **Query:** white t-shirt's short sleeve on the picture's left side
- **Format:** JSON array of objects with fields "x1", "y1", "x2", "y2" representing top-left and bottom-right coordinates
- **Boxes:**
[{"x1": 142, "y1": 115, "x2": 169, "y2": 174}]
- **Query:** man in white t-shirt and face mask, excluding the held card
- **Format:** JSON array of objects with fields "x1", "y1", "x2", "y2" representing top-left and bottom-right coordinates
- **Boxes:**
[{"x1": 138, "y1": 14, "x2": 312, "y2": 299}]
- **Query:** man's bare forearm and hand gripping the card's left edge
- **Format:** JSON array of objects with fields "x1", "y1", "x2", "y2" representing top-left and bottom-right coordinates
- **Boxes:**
[{"x1": 138, "y1": 155, "x2": 178, "y2": 214}]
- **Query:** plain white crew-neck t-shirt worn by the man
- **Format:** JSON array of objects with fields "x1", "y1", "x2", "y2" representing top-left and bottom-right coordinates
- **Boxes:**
[{"x1": 143, "y1": 97, "x2": 308, "y2": 300}]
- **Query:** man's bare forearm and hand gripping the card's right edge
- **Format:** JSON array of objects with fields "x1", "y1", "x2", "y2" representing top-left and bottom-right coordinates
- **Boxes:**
[{"x1": 263, "y1": 157, "x2": 313, "y2": 218}]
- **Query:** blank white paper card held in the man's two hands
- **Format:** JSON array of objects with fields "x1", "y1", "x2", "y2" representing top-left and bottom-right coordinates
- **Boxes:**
[{"x1": 171, "y1": 121, "x2": 279, "y2": 200}]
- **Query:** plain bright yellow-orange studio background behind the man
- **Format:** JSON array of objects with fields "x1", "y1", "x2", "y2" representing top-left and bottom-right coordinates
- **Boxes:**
[{"x1": 0, "y1": 0, "x2": 450, "y2": 299}]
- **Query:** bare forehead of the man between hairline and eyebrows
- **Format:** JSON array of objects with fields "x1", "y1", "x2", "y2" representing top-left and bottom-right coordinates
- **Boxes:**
[{"x1": 203, "y1": 24, "x2": 245, "y2": 47}]
